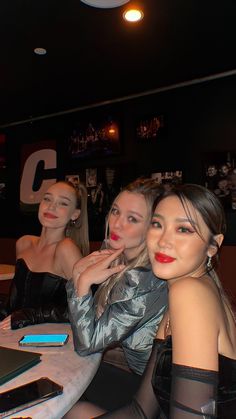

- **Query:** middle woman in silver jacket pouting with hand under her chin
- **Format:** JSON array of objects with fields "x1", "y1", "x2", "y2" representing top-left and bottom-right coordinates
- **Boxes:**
[{"x1": 67, "y1": 179, "x2": 167, "y2": 416}]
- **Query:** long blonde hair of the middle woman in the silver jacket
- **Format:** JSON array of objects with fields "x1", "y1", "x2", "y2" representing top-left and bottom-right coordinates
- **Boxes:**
[{"x1": 95, "y1": 178, "x2": 163, "y2": 317}]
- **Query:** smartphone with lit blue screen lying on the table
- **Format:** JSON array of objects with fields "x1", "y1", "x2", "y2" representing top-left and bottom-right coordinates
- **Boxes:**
[{"x1": 19, "y1": 333, "x2": 69, "y2": 346}]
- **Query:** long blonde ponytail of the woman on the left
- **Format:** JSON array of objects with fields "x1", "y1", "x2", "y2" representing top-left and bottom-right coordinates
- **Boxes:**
[{"x1": 62, "y1": 181, "x2": 89, "y2": 256}]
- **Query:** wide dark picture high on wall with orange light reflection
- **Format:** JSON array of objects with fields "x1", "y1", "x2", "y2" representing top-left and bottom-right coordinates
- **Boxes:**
[{"x1": 67, "y1": 116, "x2": 120, "y2": 159}]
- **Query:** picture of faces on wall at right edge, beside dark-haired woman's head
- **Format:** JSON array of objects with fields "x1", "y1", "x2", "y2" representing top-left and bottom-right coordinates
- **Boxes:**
[{"x1": 204, "y1": 151, "x2": 236, "y2": 210}]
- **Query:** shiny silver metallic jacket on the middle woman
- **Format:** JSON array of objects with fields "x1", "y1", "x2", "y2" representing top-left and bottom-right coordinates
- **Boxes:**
[{"x1": 66, "y1": 267, "x2": 167, "y2": 374}]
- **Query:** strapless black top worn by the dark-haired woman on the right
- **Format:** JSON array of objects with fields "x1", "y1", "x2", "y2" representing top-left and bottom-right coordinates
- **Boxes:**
[{"x1": 152, "y1": 336, "x2": 236, "y2": 419}]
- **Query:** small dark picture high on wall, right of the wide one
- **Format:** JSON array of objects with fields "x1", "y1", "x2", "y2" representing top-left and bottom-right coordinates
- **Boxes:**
[{"x1": 136, "y1": 114, "x2": 165, "y2": 142}]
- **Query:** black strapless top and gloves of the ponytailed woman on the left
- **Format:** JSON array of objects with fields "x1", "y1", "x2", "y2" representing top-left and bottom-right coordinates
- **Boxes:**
[{"x1": 2, "y1": 259, "x2": 68, "y2": 329}]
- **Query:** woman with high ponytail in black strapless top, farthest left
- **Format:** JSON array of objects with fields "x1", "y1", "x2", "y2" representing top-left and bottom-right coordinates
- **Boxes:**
[{"x1": 0, "y1": 181, "x2": 89, "y2": 329}]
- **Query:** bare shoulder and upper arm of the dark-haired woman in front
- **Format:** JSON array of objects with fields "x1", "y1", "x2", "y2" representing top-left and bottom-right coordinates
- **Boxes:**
[{"x1": 169, "y1": 276, "x2": 221, "y2": 370}]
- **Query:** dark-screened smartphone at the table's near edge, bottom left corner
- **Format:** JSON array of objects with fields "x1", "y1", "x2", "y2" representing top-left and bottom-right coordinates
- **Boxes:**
[{"x1": 0, "y1": 377, "x2": 63, "y2": 418}]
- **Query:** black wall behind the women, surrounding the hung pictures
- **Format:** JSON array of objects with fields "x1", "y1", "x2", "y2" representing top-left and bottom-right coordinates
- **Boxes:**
[{"x1": 0, "y1": 72, "x2": 236, "y2": 244}]
